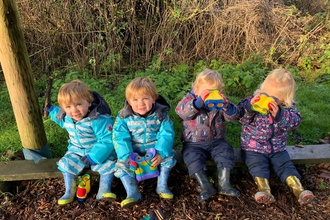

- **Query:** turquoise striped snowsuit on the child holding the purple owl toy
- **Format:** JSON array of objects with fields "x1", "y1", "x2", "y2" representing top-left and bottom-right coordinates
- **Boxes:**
[{"x1": 113, "y1": 96, "x2": 176, "y2": 178}]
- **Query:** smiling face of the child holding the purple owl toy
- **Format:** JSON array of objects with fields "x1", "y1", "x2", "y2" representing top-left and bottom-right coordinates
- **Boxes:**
[{"x1": 127, "y1": 93, "x2": 155, "y2": 115}]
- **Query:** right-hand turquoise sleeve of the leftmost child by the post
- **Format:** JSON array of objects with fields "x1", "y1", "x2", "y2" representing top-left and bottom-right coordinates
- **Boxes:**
[{"x1": 88, "y1": 115, "x2": 114, "y2": 164}]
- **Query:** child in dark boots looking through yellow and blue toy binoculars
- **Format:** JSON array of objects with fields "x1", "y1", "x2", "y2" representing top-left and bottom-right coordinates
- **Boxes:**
[{"x1": 175, "y1": 69, "x2": 239, "y2": 202}]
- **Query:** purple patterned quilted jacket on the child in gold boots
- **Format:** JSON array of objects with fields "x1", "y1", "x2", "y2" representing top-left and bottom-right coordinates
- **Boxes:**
[{"x1": 238, "y1": 96, "x2": 301, "y2": 154}]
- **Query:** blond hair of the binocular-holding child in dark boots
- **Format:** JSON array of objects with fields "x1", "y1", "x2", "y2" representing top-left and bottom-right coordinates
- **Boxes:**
[{"x1": 192, "y1": 69, "x2": 224, "y2": 92}]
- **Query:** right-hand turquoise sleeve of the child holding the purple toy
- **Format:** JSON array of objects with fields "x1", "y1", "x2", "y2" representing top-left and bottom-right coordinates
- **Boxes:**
[{"x1": 155, "y1": 115, "x2": 174, "y2": 159}]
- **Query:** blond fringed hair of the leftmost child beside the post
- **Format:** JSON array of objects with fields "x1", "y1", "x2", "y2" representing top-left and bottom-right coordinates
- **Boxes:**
[{"x1": 57, "y1": 80, "x2": 93, "y2": 108}]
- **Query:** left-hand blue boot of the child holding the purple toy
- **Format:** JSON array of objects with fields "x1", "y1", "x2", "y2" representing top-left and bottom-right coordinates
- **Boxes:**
[{"x1": 120, "y1": 175, "x2": 142, "y2": 208}]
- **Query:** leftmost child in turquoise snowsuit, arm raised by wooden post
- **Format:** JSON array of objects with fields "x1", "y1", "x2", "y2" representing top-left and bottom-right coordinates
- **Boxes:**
[{"x1": 45, "y1": 80, "x2": 116, "y2": 205}]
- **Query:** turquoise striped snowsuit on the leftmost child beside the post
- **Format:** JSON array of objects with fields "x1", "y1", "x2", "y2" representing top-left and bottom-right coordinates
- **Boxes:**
[{"x1": 49, "y1": 92, "x2": 116, "y2": 175}]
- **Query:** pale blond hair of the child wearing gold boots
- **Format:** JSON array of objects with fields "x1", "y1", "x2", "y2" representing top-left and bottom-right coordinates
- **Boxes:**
[{"x1": 257, "y1": 69, "x2": 296, "y2": 108}]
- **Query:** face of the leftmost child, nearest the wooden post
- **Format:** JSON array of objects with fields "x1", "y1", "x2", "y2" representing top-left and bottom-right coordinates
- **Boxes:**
[{"x1": 61, "y1": 99, "x2": 91, "y2": 121}]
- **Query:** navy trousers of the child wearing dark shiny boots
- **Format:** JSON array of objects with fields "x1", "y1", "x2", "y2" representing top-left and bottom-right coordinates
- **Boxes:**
[{"x1": 182, "y1": 139, "x2": 235, "y2": 175}]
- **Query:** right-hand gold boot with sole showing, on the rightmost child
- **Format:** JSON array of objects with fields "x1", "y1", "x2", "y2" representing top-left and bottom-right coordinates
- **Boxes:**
[{"x1": 285, "y1": 176, "x2": 315, "y2": 205}]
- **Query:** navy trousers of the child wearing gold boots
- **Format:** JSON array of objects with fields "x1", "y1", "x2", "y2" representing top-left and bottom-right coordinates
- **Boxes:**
[{"x1": 242, "y1": 150, "x2": 301, "y2": 183}]
